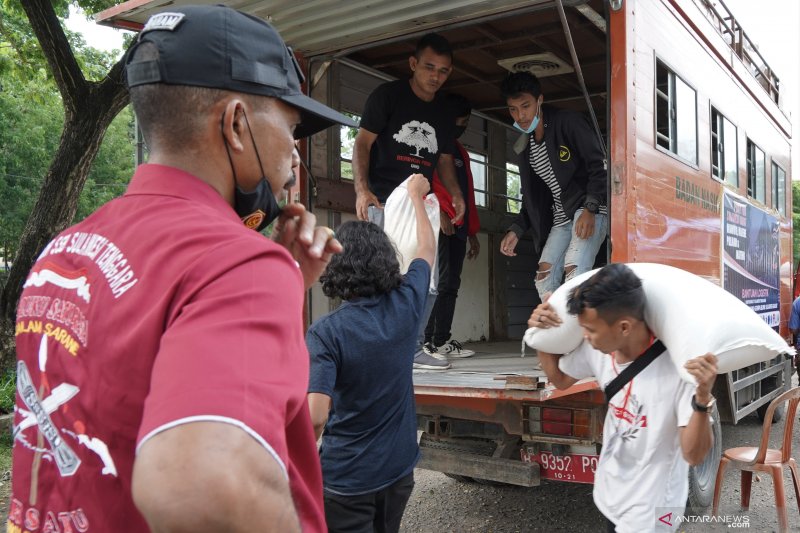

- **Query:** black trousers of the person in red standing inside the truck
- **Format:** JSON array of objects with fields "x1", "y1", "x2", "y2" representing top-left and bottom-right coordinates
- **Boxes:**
[{"x1": 425, "y1": 232, "x2": 467, "y2": 346}]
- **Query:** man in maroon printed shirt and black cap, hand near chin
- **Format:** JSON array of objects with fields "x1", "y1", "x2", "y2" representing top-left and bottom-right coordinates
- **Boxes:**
[{"x1": 7, "y1": 6, "x2": 349, "y2": 532}]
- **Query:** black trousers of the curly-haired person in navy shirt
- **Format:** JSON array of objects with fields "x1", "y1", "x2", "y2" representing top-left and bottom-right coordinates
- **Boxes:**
[{"x1": 324, "y1": 472, "x2": 414, "y2": 533}]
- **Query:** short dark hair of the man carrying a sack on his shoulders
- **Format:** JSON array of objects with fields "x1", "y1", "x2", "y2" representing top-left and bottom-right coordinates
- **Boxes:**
[{"x1": 567, "y1": 263, "x2": 647, "y2": 325}]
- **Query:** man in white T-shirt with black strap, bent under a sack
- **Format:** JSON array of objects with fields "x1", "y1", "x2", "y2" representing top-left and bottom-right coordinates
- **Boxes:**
[{"x1": 528, "y1": 263, "x2": 717, "y2": 533}]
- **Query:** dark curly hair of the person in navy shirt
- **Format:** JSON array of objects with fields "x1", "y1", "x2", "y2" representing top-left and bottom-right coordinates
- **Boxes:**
[{"x1": 319, "y1": 221, "x2": 403, "y2": 300}]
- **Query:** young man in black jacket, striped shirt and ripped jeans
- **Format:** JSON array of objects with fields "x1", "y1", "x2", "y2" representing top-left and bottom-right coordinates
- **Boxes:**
[{"x1": 500, "y1": 72, "x2": 608, "y2": 300}]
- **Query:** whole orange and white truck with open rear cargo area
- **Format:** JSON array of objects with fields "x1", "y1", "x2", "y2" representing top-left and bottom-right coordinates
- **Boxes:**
[{"x1": 96, "y1": 0, "x2": 792, "y2": 507}]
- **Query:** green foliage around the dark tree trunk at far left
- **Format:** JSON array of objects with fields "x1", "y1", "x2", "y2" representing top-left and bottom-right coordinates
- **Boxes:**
[{"x1": 0, "y1": 4, "x2": 134, "y2": 269}]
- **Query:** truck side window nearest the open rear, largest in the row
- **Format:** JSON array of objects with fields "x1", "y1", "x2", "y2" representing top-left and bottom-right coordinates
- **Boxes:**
[{"x1": 656, "y1": 60, "x2": 697, "y2": 165}]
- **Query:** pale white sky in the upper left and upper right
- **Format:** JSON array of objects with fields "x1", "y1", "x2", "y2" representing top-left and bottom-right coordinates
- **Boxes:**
[{"x1": 67, "y1": 0, "x2": 800, "y2": 180}]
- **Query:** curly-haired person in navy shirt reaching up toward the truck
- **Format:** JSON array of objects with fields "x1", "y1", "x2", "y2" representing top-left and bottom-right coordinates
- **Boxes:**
[{"x1": 306, "y1": 174, "x2": 436, "y2": 532}]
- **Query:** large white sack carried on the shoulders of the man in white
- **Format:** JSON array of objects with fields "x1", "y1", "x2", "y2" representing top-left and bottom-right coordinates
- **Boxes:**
[{"x1": 525, "y1": 263, "x2": 795, "y2": 383}]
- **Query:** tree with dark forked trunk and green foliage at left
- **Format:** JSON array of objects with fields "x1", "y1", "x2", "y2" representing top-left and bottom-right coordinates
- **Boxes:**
[{"x1": 0, "y1": 0, "x2": 133, "y2": 371}]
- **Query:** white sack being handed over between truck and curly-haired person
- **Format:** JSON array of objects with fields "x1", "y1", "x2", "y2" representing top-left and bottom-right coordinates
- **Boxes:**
[{"x1": 383, "y1": 177, "x2": 439, "y2": 290}]
